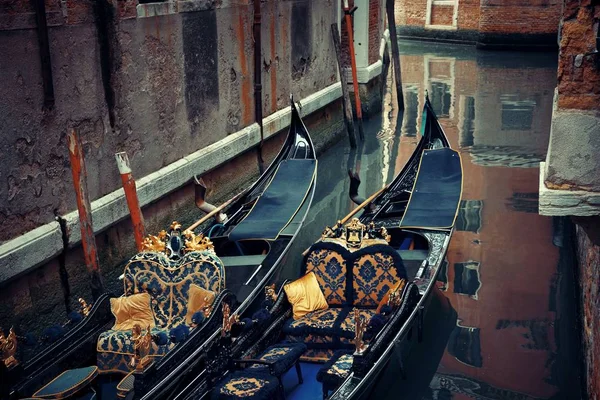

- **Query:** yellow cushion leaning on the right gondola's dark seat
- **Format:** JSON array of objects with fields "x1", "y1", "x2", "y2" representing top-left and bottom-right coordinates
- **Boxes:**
[{"x1": 283, "y1": 271, "x2": 329, "y2": 319}]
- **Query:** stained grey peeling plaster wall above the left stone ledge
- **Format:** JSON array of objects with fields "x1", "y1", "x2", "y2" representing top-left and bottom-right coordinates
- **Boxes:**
[{"x1": 0, "y1": 0, "x2": 337, "y2": 243}]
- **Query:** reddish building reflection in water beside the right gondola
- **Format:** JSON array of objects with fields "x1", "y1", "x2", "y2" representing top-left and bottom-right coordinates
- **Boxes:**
[{"x1": 397, "y1": 42, "x2": 575, "y2": 399}]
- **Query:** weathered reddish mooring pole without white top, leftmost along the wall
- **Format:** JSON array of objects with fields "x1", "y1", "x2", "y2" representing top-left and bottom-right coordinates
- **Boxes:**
[{"x1": 67, "y1": 129, "x2": 104, "y2": 301}]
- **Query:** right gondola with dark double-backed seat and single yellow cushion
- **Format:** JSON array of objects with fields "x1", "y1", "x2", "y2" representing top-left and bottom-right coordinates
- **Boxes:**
[{"x1": 171, "y1": 98, "x2": 462, "y2": 400}]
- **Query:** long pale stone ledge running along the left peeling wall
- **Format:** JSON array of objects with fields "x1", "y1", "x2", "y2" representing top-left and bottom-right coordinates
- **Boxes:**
[{"x1": 0, "y1": 82, "x2": 342, "y2": 282}]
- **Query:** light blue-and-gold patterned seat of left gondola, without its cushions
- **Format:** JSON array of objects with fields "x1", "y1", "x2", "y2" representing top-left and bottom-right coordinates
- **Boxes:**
[{"x1": 96, "y1": 236, "x2": 225, "y2": 374}]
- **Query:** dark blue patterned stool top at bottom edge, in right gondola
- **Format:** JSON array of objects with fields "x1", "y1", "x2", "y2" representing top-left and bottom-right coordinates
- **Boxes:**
[{"x1": 211, "y1": 369, "x2": 279, "y2": 400}]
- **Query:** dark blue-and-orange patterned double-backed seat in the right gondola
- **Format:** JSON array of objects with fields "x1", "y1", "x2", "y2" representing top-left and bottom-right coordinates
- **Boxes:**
[{"x1": 283, "y1": 228, "x2": 407, "y2": 362}]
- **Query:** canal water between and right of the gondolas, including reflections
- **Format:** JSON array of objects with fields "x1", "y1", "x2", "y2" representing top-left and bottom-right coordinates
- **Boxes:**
[{"x1": 284, "y1": 41, "x2": 581, "y2": 399}]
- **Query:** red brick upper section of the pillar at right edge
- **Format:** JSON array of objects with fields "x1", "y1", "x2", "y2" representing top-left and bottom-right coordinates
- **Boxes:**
[{"x1": 558, "y1": 0, "x2": 600, "y2": 110}]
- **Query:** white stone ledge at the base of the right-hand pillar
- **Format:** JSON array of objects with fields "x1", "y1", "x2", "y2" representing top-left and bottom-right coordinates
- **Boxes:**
[{"x1": 539, "y1": 162, "x2": 600, "y2": 217}]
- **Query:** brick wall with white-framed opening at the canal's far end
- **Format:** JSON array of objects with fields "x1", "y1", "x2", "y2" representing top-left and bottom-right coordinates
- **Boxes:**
[{"x1": 396, "y1": 0, "x2": 562, "y2": 49}]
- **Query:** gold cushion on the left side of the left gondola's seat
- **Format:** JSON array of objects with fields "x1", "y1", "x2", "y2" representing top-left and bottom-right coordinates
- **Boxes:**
[{"x1": 110, "y1": 293, "x2": 154, "y2": 331}]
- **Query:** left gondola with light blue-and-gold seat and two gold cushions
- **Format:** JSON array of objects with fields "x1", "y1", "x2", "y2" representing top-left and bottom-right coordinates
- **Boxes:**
[{"x1": 0, "y1": 97, "x2": 317, "y2": 400}]
